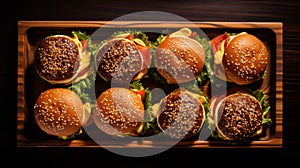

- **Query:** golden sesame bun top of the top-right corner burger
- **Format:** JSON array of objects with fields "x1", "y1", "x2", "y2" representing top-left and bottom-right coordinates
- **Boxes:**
[{"x1": 222, "y1": 33, "x2": 269, "y2": 85}]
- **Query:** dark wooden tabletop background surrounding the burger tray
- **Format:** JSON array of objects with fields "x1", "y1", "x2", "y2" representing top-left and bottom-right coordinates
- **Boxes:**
[{"x1": 0, "y1": 0, "x2": 300, "y2": 167}]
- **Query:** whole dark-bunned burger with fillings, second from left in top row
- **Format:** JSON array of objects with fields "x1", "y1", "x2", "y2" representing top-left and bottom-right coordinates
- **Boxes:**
[{"x1": 95, "y1": 31, "x2": 151, "y2": 83}]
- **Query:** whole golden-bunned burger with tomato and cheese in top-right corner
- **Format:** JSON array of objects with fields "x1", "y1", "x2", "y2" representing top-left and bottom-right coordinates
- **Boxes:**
[{"x1": 211, "y1": 32, "x2": 269, "y2": 85}]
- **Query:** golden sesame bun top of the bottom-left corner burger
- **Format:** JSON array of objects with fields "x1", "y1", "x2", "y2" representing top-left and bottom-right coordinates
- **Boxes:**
[{"x1": 34, "y1": 88, "x2": 83, "y2": 136}]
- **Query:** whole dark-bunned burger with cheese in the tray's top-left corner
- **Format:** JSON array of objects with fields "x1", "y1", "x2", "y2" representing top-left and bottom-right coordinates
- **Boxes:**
[{"x1": 34, "y1": 31, "x2": 92, "y2": 85}]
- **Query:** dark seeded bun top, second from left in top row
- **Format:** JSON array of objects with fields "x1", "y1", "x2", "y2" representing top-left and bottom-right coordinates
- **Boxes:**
[{"x1": 96, "y1": 37, "x2": 144, "y2": 83}]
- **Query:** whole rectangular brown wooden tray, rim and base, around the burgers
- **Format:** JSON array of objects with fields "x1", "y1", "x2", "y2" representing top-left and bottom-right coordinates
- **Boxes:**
[{"x1": 17, "y1": 21, "x2": 283, "y2": 148}]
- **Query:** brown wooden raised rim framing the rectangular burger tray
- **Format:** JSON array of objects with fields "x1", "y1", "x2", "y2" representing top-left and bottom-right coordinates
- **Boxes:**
[{"x1": 17, "y1": 20, "x2": 283, "y2": 148}]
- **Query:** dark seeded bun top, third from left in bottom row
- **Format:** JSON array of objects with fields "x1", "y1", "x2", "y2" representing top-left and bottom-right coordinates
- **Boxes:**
[{"x1": 157, "y1": 90, "x2": 206, "y2": 138}]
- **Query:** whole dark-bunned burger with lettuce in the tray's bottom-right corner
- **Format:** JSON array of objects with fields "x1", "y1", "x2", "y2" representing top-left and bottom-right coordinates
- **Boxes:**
[{"x1": 208, "y1": 88, "x2": 271, "y2": 142}]
